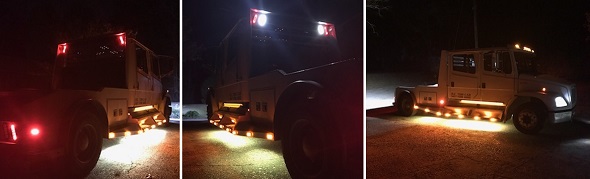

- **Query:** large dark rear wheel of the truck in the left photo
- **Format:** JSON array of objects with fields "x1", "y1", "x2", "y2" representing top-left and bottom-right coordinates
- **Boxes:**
[{"x1": 64, "y1": 112, "x2": 102, "y2": 178}]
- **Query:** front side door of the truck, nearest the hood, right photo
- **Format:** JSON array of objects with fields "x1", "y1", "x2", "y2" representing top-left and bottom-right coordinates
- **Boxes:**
[{"x1": 480, "y1": 51, "x2": 516, "y2": 105}]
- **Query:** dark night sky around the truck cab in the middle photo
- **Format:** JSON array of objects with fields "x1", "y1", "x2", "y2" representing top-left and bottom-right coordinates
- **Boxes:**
[{"x1": 182, "y1": 0, "x2": 363, "y2": 103}]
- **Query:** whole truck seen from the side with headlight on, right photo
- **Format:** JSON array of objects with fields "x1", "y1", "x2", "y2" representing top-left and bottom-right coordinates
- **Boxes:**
[{"x1": 394, "y1": 44, "x2": 577, "y2": 134}]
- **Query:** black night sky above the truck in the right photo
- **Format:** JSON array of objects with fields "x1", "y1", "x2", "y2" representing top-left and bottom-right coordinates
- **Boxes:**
[{"x1": 367, "y1": 0, "x2": 590, "y2": 81}]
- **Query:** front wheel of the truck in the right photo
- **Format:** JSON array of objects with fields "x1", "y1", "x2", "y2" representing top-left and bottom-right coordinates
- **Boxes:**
[{"x1": 513, "y1": 104, "x2": 546, "y2": 134}]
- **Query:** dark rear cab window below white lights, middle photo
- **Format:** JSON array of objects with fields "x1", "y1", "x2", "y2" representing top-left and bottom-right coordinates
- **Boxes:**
[{"x1": 250, "y1": 13, "x2": 342, "y2": 77}]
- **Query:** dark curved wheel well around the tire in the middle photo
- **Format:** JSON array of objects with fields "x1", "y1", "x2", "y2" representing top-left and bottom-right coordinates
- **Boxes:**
[{"x1": 273, "y1": 81, "x2": 322, "y2": 140}]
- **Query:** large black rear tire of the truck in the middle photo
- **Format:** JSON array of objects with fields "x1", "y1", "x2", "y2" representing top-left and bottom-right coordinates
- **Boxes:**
[{"x1": 281, "y1": 105, "x2": 346, "y2": 178}]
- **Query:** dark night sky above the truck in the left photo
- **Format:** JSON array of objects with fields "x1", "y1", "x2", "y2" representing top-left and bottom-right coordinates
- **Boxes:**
[{"x1": 0, "y1": 0, "x2": 180, "y2": 63}]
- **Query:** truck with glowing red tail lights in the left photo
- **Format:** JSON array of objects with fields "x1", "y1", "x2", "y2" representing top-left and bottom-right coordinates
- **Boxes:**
[{"x1": 0, "y1": 33, "x2": 171, "y2": 178}]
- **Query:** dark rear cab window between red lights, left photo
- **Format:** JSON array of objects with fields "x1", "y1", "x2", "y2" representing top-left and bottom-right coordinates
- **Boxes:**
[{"x1": 58, "y1": 35, "x2": 126, "y2": 90}]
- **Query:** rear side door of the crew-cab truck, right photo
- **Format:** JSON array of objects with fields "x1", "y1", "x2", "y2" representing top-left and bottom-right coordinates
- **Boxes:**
[{"x1": 447, "y1": 53, "x2": 481, "y2": 103}]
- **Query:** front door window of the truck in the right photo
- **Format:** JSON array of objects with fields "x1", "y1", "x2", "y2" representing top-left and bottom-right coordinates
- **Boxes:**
[{"x1": 483, "y1": 52, "x2": 512, "y2": 74}]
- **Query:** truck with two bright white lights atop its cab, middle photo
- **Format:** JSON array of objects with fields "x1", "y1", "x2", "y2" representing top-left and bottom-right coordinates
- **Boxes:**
[{"x1": 206, "y1": 9, "x2": 364, "y2": 178}]
